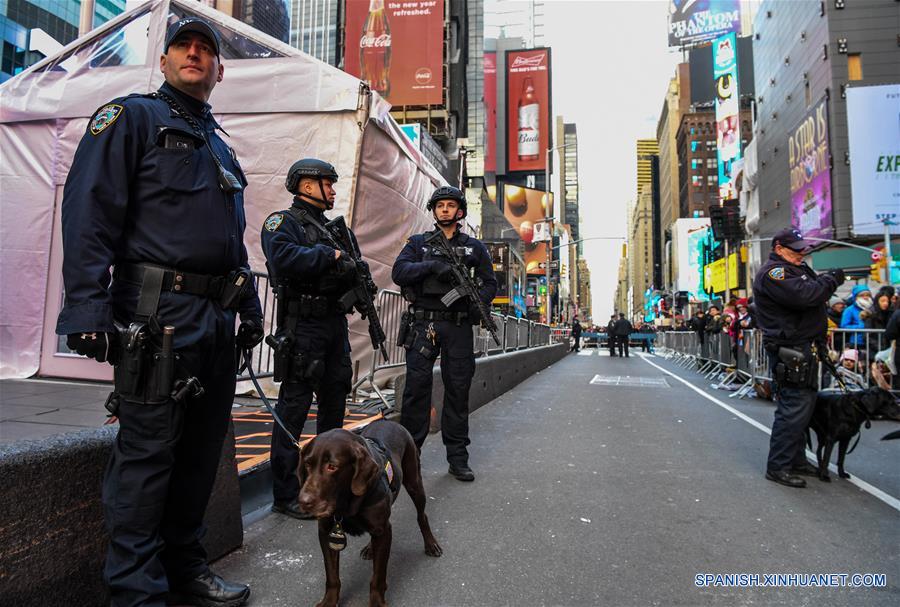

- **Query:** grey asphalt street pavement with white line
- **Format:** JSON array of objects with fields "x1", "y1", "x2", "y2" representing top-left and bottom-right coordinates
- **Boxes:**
[{"x1": 215, "y1": 351, "x2": 900, "y2": 607}]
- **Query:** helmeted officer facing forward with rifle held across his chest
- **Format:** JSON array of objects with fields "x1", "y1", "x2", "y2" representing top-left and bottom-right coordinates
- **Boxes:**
[{"x1": 392, "y1": 186, "x2": 497, "y2": 481}]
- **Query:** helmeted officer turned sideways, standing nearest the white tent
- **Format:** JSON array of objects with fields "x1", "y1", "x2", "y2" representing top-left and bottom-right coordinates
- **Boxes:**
[{"x1": 261, "y1": 158, "x2": 356, "y2": 519}]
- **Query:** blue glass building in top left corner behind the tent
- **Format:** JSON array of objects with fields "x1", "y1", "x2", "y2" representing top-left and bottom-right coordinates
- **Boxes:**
[{"x1": 0, "y1": 0, "x2": 125, "y2": 82}]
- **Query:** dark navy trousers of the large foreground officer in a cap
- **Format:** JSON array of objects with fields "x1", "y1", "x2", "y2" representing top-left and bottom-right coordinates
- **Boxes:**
[{"x1": 103, "y1": 320, "x2": 236, "y2": 607}]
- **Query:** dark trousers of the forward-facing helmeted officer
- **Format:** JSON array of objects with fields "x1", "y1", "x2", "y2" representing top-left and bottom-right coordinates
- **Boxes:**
[{"x1": 400, "y1": 320, "x2": 475, "y2": 465}]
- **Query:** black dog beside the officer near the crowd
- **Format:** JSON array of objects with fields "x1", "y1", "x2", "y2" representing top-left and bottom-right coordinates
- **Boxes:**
[{"x1": 807, "y1": 388, "x2": 900, "y2": 482}]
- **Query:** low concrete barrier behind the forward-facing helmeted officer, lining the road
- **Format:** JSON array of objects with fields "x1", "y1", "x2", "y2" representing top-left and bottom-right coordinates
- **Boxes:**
[{"x1": 395, "y1": 343, "x2": 570, "y2": 432}]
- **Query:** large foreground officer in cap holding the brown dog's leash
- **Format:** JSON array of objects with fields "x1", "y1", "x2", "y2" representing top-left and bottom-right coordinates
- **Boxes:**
[{"x1": 56, "y1": 18, "x2": 263, "y2": 607}]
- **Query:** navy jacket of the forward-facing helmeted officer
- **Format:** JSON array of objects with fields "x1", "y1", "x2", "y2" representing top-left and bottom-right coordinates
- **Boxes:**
[{"x1": 391, "y1": 230, "x2": 497, "y2": 312}]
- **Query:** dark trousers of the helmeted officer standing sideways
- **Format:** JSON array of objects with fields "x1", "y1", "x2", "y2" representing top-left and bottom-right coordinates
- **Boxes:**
[{"x1": 271, "y1": 314, "x2": 353, "y2": 502}]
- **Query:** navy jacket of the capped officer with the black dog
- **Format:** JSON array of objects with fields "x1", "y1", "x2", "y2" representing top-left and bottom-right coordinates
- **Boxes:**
[{"x1": 753, "y1": 252, "x2": 838, "y2": 346}]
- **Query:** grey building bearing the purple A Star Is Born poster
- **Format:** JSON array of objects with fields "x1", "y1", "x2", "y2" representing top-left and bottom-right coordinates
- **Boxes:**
[{"x1": 751, "y1": 0, "x2": 900, "y2": 273}]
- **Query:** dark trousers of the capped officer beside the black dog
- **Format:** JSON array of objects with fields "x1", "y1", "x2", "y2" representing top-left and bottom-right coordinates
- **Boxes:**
[{"x1": 766, "y1": 348, "x2": 817, "y2": 472}]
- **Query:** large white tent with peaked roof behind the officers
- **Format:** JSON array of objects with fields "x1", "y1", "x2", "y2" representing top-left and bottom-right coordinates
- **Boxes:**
[{"x1": 0, "y1": 0, "x2": 444, "y2": 379}]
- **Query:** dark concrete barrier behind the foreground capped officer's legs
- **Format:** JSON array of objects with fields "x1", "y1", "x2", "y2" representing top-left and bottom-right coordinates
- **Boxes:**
[{"x1": 0, "y1": 426, "x2": 244, "y2": 607}]
